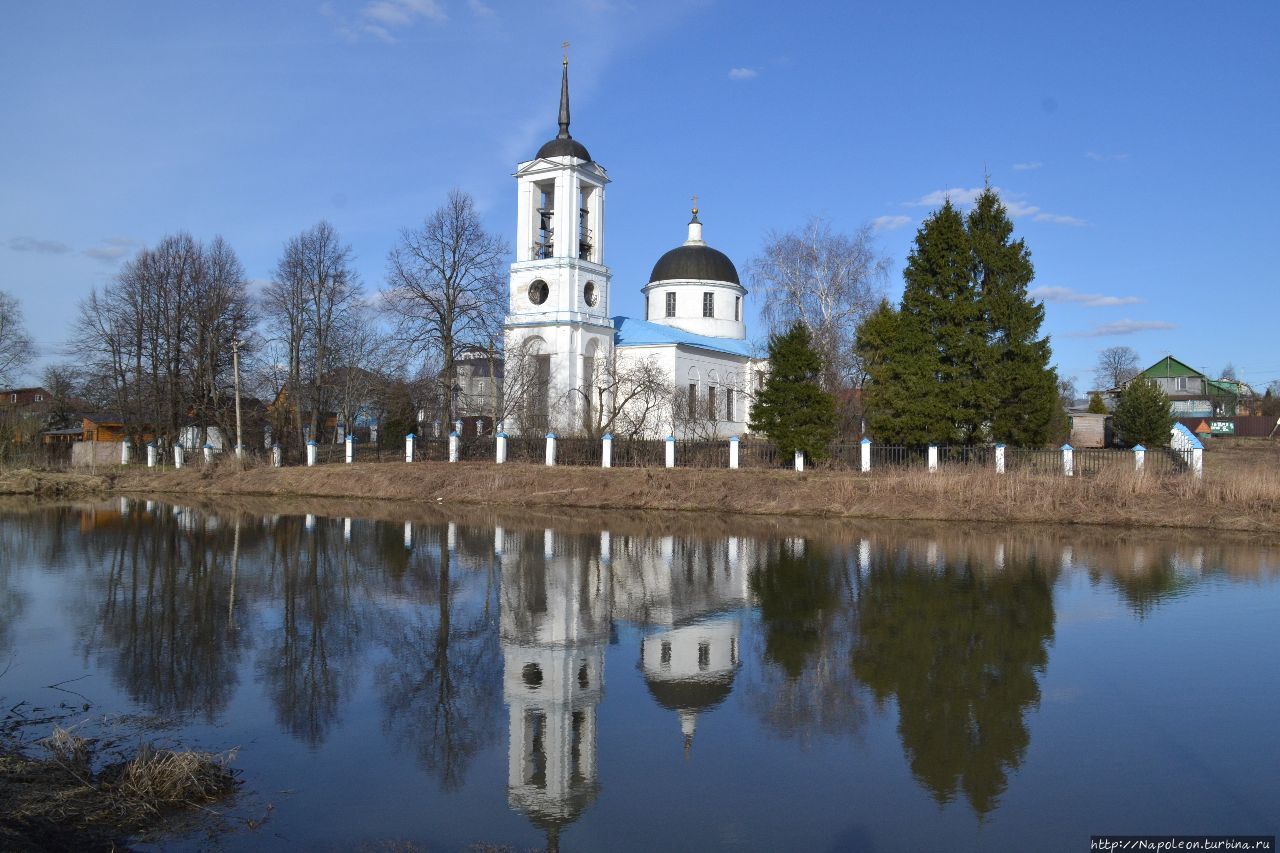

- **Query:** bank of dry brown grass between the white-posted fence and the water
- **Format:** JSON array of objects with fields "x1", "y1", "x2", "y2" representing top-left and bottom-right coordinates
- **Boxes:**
[{"x1": 0, "y1": 460, "x2": 1280, "y2": 533}]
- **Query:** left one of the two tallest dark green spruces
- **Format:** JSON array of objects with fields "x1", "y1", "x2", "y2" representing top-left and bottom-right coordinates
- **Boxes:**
[{"x1": 899, "y1": 200, "x2": 992, "y2": 443}]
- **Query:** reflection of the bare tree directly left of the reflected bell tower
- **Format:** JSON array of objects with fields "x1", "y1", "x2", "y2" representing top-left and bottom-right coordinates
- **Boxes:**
[{"x1": 374, "y1": 528, "x2": 502, "y2": 790}]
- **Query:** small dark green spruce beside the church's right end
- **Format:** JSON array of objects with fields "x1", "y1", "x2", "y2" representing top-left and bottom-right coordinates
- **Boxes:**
[{"x1": 750, "y1": 323, "x2": 836, "y2": 460}]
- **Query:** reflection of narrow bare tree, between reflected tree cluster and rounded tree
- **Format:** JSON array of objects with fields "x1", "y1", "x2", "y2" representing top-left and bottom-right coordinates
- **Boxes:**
[{"x1": 257, "y1": 517, "x2": 361, "y2": 745}]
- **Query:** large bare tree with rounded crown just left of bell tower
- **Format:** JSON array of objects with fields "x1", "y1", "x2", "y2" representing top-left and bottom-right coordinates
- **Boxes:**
[{"x1": 385, "y1": 190, "x2": 508, "y2": 423}]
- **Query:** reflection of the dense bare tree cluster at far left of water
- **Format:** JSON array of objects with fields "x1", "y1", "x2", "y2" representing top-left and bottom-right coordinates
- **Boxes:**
[{"x1": 83, "y1": 512, "x2": 241, "y2": 720}]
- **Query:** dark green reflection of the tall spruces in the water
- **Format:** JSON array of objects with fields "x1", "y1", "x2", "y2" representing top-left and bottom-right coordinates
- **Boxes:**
[{"x1": 852, "y1": 565, "x2": 1053, "y2": 815}]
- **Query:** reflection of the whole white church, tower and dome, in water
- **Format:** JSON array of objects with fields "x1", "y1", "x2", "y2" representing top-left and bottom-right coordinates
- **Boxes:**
[{"x1": 494, "y1": 528, "x2": 755, "y2": 849}]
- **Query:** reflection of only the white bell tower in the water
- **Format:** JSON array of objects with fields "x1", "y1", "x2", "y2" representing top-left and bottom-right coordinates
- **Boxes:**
[{"x1": 495, "y1": 530, "x2": 609, "y2": 849}]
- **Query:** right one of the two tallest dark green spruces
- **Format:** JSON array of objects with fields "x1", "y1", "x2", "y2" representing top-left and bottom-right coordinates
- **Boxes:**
[{"x1": 968, "y1": 186, "x2": 1061, "y2": 447}]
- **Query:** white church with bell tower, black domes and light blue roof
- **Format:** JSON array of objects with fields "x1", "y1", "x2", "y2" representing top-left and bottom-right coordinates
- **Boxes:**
[{"x1": 504, "y1": 59, "x2": 765, "y2": 438}]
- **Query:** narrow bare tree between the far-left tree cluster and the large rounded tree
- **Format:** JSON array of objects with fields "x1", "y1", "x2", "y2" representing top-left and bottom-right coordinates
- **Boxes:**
[{"x1": 262, "y1": 222, "x2": 361, "y2": 443}]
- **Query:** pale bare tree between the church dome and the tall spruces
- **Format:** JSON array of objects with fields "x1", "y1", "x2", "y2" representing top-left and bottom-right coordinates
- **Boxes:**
[{"x1": 750, "y1": 216, "x2": 888, "y2": 391}]
